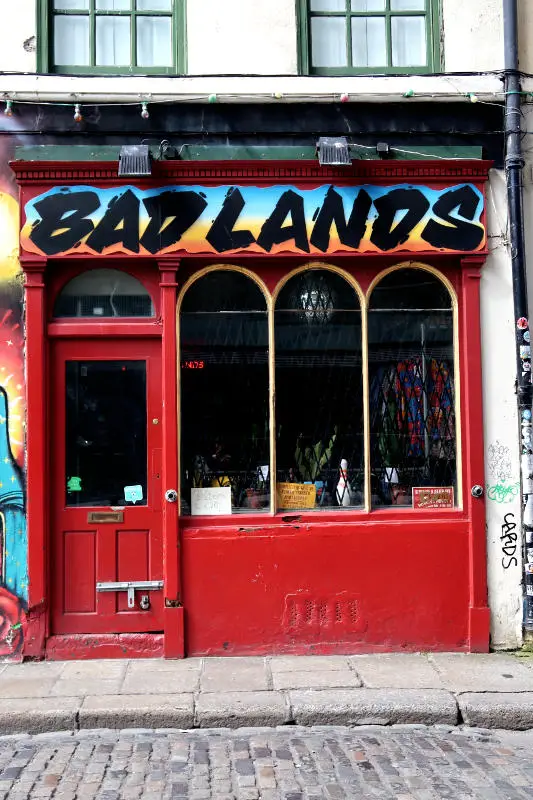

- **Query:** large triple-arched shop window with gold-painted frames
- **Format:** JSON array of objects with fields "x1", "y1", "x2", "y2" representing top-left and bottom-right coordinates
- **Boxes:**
[{"x1": 179, "y1": 265, "x2": 457, "y2": 514}]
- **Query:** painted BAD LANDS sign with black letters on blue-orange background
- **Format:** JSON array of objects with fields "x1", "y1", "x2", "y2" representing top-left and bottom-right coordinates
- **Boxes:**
[{"x1": 21, "y1": 183, "x2": 486, "y2": 256}]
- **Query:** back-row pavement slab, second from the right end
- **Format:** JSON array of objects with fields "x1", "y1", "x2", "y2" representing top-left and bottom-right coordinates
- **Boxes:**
[{"x1": 349, "y1": 653, "x2": 445, "y2": 689}]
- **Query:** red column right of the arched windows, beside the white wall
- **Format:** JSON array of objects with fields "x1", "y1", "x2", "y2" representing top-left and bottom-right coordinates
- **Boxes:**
[{"x1": 460, "y1": 257, "x2": 490, "y2": 652}]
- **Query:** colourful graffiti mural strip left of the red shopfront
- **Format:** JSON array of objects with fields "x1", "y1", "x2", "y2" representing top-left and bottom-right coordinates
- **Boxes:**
[{"x1": 0, "y1": 128, "x2": 28, "y2": 660}]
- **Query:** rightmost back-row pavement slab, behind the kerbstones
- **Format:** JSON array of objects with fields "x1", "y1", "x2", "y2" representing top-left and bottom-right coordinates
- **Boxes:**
[{"x1": 429, "y1": 653, "x2": 533, "y2": 693}]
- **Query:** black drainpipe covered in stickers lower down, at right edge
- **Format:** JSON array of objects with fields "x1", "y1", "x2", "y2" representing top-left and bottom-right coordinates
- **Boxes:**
[{"x1": 503, "y1": 0, "x2": 533, "y2": 635}]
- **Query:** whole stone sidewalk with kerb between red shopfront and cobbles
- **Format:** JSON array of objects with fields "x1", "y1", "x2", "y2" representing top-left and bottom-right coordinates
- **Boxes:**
[{"x1": 0, "y1": 653, "x2": 533, "y2": 734}]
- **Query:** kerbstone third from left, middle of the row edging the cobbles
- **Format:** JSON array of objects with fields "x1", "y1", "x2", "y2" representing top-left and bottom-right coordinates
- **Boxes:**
[{"x1": 195, "y1": 691, "x2": 291, "y2": 728}]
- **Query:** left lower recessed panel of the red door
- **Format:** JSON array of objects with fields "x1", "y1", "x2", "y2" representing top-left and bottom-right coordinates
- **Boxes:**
[{"x1": 63, "y1": 531, "x2": 96, "y2": 614}]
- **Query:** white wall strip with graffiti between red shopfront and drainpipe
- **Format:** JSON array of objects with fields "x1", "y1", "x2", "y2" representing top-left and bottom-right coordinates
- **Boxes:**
[{"x1": 481, "y1": 170, "x2": 522, "y2": 649}]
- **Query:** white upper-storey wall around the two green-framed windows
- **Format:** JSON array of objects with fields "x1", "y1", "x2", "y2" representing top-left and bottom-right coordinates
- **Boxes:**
[{"x1": 0, "y1": 0, "x2": 512, "y2": 75}]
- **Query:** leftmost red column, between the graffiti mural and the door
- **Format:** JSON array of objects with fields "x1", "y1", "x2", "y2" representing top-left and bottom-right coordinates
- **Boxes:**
[{"x1": 22, "y1": 258, "x2": 49, "y2": 657}]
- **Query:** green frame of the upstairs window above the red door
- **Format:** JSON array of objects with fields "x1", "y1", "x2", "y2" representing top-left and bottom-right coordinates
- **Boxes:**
[{"x1": 37, "y1": 0, "x2": 186, "y2": 75}]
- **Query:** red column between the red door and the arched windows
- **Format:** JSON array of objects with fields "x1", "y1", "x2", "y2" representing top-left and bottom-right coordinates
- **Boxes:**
[{"x1": 159, "y1": 259, "x2": 185, "y2": 658}]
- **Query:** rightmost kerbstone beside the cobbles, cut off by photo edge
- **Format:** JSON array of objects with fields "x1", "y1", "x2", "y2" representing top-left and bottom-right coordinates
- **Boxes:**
[{"x1": 457, "y1": 692, "x2": 533, "y2": 732}]
